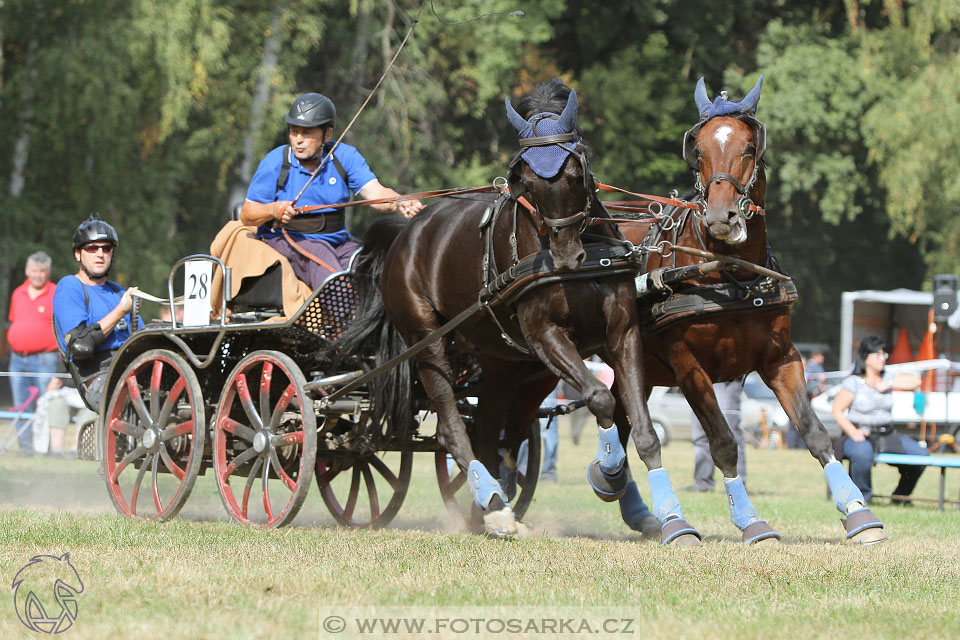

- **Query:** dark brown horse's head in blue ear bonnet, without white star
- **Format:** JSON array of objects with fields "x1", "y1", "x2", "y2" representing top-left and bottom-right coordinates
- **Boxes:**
[{"x1": 506, "y1": 80, "x2": 594, "y2": 271}]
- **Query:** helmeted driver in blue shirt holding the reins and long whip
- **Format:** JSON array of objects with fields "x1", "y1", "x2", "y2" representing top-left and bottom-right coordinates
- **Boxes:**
[{"x1": 240, "y1": 93, "x2": 423, "y2": 290}]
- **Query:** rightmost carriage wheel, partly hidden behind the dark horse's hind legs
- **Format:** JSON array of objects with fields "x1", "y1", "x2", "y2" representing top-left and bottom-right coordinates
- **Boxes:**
[{"x1": 434, "y1": 420, "x2": 540, "y2": 528}]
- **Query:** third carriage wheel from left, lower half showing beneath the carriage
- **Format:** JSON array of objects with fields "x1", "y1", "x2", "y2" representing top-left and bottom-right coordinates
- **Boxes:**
[{"x1": 317, "y1": 451, "x2": 413, "y2": 529}]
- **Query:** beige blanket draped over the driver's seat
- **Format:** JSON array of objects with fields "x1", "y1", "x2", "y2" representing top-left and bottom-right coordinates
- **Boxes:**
[{"x1": 210, "y1": 220, "x2": 313, "y2": 321}]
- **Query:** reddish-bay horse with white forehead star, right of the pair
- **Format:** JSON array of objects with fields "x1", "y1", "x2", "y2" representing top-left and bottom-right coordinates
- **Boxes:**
[{"x1": 604, "y1": 76, "x2": 886, "y2": 544}]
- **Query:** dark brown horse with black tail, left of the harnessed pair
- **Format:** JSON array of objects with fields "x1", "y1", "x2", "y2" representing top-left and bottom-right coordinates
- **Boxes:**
[{"x1": 337, "y1": 80, "x2": 656, "y2": 536}]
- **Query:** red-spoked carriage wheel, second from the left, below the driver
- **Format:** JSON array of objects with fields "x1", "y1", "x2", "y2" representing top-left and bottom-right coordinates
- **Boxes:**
[{"x1": 213, "y1": 351, "x2": 317, "y2": 527}]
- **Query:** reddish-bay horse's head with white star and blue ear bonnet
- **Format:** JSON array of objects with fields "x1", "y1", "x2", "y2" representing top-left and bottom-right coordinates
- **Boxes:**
[{"x1": 683, "y1": 76, "x2": 766, "y2": 245}]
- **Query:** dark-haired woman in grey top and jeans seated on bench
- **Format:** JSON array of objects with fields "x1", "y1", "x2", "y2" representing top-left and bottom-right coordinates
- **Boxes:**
[{"x1": 833, "y1": 336, "x2": 929, "y2": 503}]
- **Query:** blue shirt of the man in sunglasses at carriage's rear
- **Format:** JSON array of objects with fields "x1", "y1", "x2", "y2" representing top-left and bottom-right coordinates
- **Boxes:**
[{"x1": 53, "y1": 276, "x2": 143, "y2": 353}]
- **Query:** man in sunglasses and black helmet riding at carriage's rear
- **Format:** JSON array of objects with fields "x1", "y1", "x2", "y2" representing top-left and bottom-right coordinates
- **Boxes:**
[{"x1": 53, "y1": 214, "x2": 143, "y2": 410}]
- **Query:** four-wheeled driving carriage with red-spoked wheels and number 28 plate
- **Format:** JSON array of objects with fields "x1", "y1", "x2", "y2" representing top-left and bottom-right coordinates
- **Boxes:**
[{"x1": 71, "y1": 255, "x2": 563, "y2": 527}]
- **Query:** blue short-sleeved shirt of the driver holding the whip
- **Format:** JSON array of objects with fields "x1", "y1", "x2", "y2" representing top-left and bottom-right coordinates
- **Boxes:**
[{"x1": 247, "y1": 142, "x2": 377, "y2": 246}]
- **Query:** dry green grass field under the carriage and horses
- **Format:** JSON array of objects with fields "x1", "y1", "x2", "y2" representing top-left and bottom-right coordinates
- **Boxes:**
[{"x1": 0, "y1": 423, "x2": 960, "y2": 640}]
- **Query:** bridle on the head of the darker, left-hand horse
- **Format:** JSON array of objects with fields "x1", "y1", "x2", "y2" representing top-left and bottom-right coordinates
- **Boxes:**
[{"x1": 507, "y1": 113, "x2": 596, "y2": 235}]
